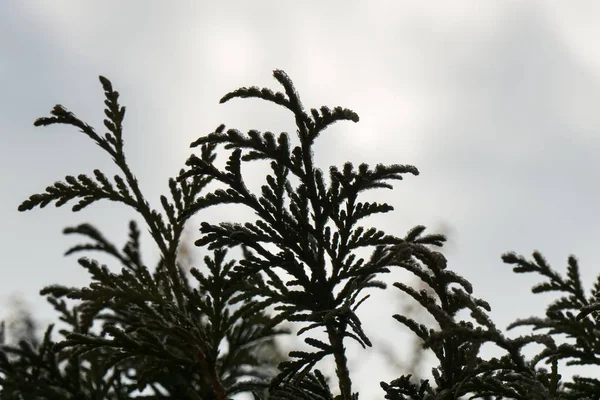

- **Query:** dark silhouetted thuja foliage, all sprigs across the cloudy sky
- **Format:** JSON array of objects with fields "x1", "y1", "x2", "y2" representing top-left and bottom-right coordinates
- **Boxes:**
[{"x1": 0, "y1": 70, "x2": 600, "y2": 400}]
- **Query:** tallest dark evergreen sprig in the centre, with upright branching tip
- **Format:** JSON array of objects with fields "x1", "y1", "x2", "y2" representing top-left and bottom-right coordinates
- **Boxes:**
[{"x1": 179, "y1": 70, "x2": 426, "y2": 398}]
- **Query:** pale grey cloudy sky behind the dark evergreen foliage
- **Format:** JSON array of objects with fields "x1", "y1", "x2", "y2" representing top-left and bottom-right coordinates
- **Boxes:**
[{"x1": 0, "y1": 0, "x2": 600, "y2": 399}]
